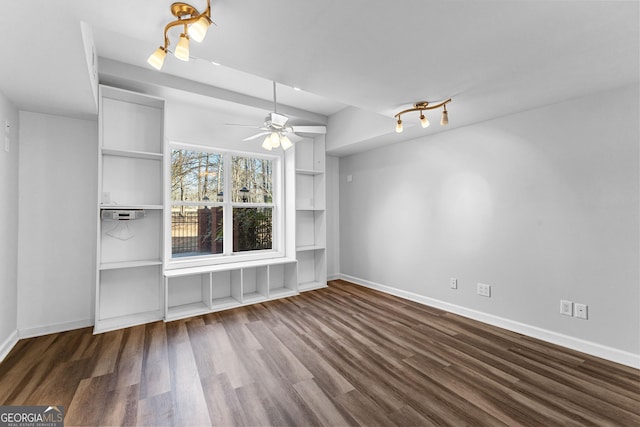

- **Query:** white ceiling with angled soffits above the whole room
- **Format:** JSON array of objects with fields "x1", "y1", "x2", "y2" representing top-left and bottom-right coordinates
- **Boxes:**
[{"x1": 0, "y1": 0, "x2": 640, "y2": 154}]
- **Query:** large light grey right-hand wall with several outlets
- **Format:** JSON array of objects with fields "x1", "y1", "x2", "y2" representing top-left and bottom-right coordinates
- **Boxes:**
[{"x1": 340, "y1": 85, "x2": 640, "y2": 364}]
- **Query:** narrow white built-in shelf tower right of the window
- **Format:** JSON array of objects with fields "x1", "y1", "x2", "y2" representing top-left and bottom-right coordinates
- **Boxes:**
[{"x1": 295, "y1": 135, "x2": 327, "y2": 291}]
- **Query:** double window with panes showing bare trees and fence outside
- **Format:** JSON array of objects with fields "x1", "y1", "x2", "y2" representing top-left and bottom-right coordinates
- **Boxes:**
[{"x1": 171, "y1": 144, "x2": 279, "y2": 261}]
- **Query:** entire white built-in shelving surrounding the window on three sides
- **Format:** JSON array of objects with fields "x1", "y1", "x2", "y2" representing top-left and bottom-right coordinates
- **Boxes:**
[{"x1": 94, "y1": 86, "x2": 327, "y2": 333}]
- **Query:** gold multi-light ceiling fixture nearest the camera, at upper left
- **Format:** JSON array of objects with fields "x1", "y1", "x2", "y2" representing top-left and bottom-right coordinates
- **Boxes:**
[{"x1": 147, "y1": 0, "x2": 212, "y2": 70}]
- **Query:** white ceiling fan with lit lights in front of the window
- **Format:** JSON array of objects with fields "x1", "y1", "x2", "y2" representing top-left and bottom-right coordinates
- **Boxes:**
[{"x1": 229, "y1": 81, "x2": 327, "y2": 151}]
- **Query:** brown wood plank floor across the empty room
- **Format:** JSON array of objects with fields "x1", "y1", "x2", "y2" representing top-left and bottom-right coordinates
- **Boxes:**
[{"x1": 0, "y1": 281, "x2": 640, "y2": 426}]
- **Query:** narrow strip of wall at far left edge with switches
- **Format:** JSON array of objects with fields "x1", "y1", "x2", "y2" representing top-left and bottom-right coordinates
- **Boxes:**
[{"x1": 0, "y1": 93, "x2": 19, "y2": 360}]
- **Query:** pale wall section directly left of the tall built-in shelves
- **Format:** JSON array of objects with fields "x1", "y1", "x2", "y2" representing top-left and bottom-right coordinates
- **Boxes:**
[{"x1": 18, "y1": 111, "x2": 98, "y2": 337}]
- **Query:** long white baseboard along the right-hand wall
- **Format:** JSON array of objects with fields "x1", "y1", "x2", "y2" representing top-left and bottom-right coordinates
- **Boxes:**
[{"x1": 339, "y1": 274, "x2": 640, "y2": 369}]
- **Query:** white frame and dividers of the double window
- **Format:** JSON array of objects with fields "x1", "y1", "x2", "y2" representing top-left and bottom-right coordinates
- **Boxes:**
[{"x1": 163, "y1": 141, "x2": 285, "y2": 270}]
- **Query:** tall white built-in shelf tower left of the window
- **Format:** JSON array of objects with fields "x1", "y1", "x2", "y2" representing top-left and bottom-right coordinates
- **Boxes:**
[{"x1": 94, "y1": 86, "x2": 165, "y2": 333}]
